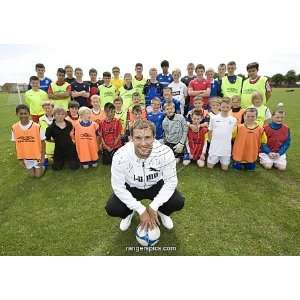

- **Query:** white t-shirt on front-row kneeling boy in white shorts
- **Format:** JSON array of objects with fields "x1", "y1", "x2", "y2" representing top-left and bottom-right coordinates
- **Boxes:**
[{"x1": 208, "y1": 114, "x2": 236, "y2": 156}]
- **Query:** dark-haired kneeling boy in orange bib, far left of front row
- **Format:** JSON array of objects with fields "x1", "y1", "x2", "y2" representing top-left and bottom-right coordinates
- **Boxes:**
[{"x1": 11, "y1": 104, "x2": 45, "y2": 178}]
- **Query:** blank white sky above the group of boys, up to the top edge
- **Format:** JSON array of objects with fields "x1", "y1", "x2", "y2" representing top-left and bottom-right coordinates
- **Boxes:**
[{"x1": 0, "y1": 0, "x2": 300, "y2": 84}]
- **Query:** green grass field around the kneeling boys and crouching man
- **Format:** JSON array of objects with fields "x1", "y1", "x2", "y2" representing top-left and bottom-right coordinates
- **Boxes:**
[{"x1": 0, "y1": 89, "x2": 300, "y2": 255}]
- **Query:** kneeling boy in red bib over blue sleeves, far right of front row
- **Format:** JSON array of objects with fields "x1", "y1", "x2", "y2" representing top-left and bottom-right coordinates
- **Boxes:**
[{"x1": 259, "y1": 110, "x2": 291, "y2": 171}]
